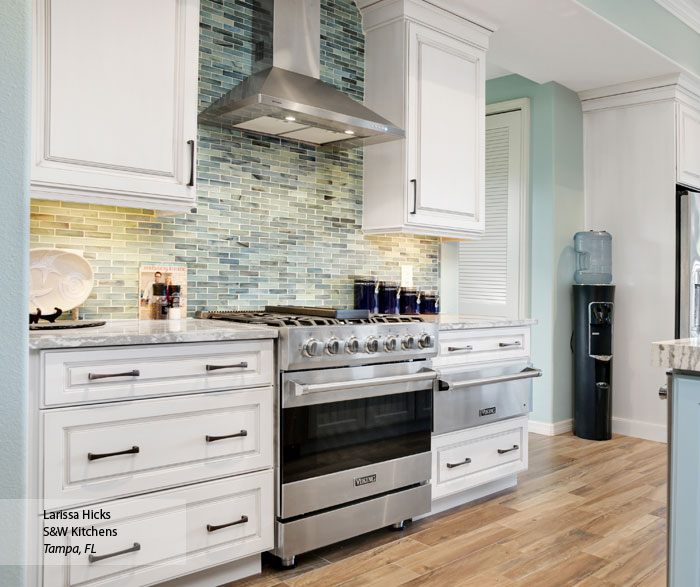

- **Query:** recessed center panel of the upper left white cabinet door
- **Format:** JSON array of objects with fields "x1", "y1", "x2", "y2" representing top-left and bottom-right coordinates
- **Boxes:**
[{"x1": 45, "y1": 0, "x2": 178, "y2": 177}]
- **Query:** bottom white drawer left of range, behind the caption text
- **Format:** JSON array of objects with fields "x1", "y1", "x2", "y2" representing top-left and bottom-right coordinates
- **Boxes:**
[{"x1": 42, "y1": 470, "x2": 274, "y2": 587}]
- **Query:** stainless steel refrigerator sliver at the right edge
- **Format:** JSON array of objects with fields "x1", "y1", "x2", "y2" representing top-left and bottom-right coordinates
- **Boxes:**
[{"x1": 676, "y1": 186, "x2": 700, "y2": 338}]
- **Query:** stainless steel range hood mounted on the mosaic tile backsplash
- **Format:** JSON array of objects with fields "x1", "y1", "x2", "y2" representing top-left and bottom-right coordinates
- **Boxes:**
[{"x1": 199, "y1": 0, "x2": 405, "y2": 148}]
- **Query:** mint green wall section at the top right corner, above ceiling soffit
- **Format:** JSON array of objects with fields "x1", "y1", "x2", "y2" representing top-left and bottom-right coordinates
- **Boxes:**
[{"x1": 577, "y1": 0, "x2": 700, "y2": 75}]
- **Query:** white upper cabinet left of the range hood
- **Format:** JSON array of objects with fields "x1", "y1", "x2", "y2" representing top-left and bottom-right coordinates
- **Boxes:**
[{"x1": 31, "y1": 0, "x2": 199, "y2": 211}]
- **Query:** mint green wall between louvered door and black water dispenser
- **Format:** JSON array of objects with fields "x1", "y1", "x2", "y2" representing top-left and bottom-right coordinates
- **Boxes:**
[{"x1": 486, "y1": 75, "x2": 583, "y2": 423}]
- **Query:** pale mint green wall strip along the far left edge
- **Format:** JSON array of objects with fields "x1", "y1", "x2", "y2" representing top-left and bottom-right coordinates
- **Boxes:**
[{"x1": 0, "y1": 0, "x2": 31, "y2": 587}]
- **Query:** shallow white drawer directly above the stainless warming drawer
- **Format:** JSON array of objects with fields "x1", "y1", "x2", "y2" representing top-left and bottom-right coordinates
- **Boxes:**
[{"x1": 433, "y1": 327, "x2": 530, "y2": 366}]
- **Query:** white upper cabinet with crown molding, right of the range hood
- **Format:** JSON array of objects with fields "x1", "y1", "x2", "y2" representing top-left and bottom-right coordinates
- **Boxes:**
[{"x1": 358, "y1": 0, "x2": 488, "y2": 238}]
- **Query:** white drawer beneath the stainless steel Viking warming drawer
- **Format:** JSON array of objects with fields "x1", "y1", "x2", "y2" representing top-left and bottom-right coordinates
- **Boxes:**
[{"x1": 432, "y1": 417, "x2": 527, "y2": 499}]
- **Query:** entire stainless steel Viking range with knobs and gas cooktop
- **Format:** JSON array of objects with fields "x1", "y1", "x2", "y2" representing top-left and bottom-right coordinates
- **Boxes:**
[{"x1": 200, "y1": 306, "x2": 438, "y2": 566}]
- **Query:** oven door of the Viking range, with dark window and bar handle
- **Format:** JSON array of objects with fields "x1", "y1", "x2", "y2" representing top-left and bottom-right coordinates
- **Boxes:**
[{"x1": 279, "y1": 361, "x2": 435, "y2": 519}]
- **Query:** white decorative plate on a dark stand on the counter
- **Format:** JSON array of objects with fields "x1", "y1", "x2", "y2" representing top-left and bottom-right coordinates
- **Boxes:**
[{"x1": 29, "y1": 249, "x2": 94, "y2": 314}]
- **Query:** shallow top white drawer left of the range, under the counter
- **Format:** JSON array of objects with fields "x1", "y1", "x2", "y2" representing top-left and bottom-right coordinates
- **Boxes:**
[{"x1": 39, "y1": 340, "x2": 274, "y2": 406}]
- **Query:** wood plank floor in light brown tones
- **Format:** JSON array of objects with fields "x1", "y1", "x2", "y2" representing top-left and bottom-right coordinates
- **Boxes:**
[{"x1": 228, "y1": 434, "x2": 666, "y2": 587}]
